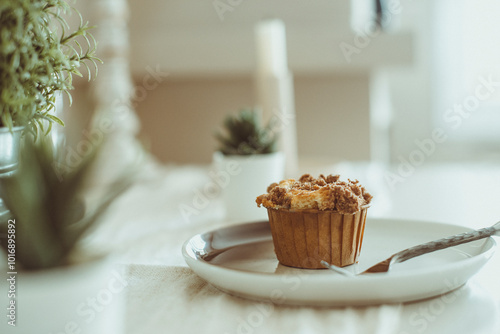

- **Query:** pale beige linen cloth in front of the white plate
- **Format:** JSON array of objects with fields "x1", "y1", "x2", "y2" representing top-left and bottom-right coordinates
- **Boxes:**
[{"x1": 126, "y1": 265, "x2": 500, "y2": 334}]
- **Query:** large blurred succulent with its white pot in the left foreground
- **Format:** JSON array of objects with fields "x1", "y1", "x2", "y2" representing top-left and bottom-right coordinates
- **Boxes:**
[{"x1": 0, "y1": 138, "x2": 131, "y2": 333}]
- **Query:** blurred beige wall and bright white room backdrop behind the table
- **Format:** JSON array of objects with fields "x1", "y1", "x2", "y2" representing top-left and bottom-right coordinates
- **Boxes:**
[{"x1": 71, "y1": 0, "x2": 500, "y2": 164}]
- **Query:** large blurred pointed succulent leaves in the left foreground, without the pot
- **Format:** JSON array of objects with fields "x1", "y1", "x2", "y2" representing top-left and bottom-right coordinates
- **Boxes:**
[{"x1": 0, "y1": 138, "x2": 131, "y2": 270}]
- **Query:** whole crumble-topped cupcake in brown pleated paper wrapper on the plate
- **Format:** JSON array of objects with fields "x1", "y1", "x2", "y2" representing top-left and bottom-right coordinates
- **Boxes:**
[{"x1": 256, "y1": 174, "x2": 372, "y2": 269}]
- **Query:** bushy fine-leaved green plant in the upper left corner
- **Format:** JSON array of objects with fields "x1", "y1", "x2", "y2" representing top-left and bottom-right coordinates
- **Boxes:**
[{"x1": 0, "y1": 0, "x2": 100, "y2": 134}]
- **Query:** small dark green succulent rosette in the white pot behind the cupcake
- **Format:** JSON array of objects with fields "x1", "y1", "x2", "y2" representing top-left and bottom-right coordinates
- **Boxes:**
[{"x1": 215, "y1": 109, "x2": 277, "y2": 155}]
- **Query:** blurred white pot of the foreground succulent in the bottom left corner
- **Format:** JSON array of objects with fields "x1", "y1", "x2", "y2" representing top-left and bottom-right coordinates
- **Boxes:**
[{"x1": 0, "y1": 259, "x2": 127, "y2": 334}]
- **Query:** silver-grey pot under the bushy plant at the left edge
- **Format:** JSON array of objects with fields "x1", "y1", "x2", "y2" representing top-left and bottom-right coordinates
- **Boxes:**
[{"x1": 0, "y1": 126, "x2": 24, "y2": 221}]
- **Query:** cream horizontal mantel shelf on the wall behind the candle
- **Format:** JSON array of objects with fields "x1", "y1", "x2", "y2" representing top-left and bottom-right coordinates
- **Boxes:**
[{"x1": 131, "y1": 27, "x2": 413, "y2": 76}]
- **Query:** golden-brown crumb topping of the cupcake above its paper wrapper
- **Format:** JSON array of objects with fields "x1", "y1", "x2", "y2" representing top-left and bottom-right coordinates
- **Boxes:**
[{"x1": 255, "y1": 174, "x2": 373, "y2": 214}]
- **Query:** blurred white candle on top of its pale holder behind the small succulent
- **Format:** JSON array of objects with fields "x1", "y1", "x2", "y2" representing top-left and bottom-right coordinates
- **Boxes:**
[{"x1": 255, "y1": 19, "x2": 288, "y2": 75}]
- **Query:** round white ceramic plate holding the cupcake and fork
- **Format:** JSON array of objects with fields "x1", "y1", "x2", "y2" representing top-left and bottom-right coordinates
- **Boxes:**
[{"x1": 182, "y1": 219, "x2": 496, "y2": 306}]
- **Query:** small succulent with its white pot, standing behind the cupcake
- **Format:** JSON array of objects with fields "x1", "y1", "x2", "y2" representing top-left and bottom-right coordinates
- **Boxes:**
[{"x1": 213, "y1": 109, "x2": 284, "y2": 222}]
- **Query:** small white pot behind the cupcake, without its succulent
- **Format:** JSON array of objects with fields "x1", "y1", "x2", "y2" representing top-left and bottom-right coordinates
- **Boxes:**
[{"x1": 212, "y1": 152, "x2": 285, "y2": 223}]
